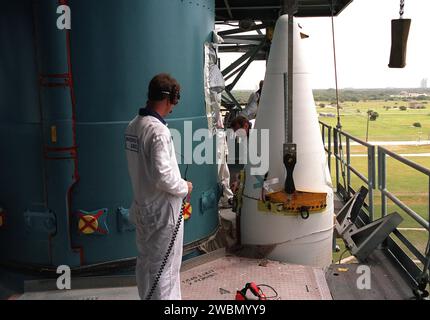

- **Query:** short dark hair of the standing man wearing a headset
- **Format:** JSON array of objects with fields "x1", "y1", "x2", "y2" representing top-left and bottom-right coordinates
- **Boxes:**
[{"x1": 148, "y1": 73, "x2": 181, "y2": 104}]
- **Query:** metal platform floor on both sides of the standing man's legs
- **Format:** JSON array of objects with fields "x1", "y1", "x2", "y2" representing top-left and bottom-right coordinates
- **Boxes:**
[{"x1": 15, "y1": 253, "x2": 331, "y2": 300}]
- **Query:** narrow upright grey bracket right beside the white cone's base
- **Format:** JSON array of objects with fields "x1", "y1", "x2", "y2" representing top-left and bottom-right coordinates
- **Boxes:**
[{"x1": 335, "y1": 187, "x2": 368, "y2": 236}]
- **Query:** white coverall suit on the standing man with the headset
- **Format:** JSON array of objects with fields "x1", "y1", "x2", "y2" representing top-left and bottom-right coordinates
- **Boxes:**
[{"x1": 126, "y1": 109, "x2": 188, "y2": 300}]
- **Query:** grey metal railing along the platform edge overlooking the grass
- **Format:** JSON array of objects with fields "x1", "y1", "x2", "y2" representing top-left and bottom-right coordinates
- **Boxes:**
[{"x1": 320, "y1": 122, "x2": 430, "y2": 287}]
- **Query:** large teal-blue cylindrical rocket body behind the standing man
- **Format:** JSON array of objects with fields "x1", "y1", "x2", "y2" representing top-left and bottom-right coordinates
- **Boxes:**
[{"x1": 0, "y1": 0, "x2": 218, "y2": 266}]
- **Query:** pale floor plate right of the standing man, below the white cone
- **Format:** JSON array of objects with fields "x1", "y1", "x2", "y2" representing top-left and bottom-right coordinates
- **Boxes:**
[{"x1": 181, "y1": 256, "x2": 331, "y2": 300}]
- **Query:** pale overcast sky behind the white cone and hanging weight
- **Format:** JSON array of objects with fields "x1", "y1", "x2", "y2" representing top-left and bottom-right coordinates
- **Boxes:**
[{"x1": 220, "y1": 0, "x2": 430, "y2": 90}]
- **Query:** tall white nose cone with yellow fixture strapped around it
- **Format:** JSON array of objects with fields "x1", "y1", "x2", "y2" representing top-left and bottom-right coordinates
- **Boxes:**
[{"x1": 241, "y1": 15, "x2": 334, "y2": 267}]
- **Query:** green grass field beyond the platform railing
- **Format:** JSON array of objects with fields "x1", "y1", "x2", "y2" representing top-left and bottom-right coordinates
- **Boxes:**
[{"x1": 317, "y1": 101, "x2": 430, "y2": 261}]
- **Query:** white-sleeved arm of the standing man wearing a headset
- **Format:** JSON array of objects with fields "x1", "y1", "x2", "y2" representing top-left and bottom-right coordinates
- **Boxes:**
[{"x1": 151, "y1": 134, "x2": 188, "y2": 198}]
